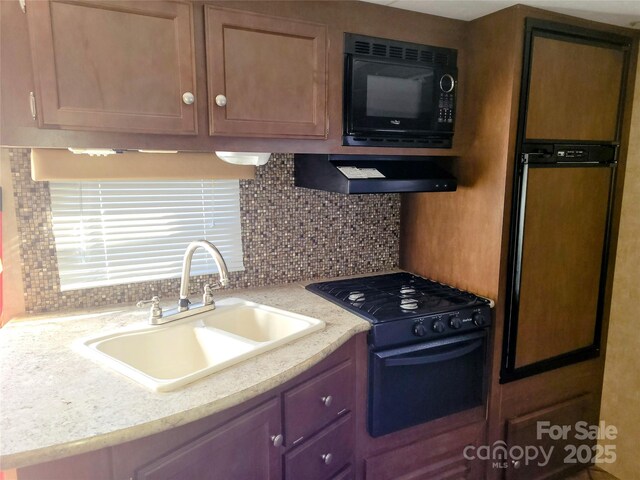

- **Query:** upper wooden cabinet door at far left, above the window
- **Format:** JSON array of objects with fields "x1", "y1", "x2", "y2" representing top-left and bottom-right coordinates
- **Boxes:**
[{"x1": 27, "y1": 0, "x2": 197, "y2": 134}]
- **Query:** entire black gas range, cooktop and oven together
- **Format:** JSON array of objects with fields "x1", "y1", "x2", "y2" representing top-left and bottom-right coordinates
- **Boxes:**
[{"x1": 307, "y1": 272, "x2": 491, "y2": 437}]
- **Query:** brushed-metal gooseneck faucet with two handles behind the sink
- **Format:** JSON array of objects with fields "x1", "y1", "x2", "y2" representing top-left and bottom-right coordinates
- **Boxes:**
[{"x1": 137, "y1": 240, "x2": 229, "y2": 325}]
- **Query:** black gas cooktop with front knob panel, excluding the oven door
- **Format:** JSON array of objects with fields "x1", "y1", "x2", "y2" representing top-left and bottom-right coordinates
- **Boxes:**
[{"x1": 307, "y1": 272, "x2": 491, "y2": 348}]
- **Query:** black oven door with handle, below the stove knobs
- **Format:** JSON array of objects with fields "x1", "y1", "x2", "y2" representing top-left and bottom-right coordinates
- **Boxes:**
[{"x1": 368, "y1": 329, "x2": 487, "y2": 437}]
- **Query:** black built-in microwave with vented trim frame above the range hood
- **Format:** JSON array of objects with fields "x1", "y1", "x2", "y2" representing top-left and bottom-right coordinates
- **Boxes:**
[{"x1": 343, "y1": 33, "x2": 458, "y2": 148}]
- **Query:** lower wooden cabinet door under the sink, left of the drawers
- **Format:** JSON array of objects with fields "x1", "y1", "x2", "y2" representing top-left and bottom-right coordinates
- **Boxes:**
[{"x1": 135, "y1": 398, "x2": 282, "y2": 480}]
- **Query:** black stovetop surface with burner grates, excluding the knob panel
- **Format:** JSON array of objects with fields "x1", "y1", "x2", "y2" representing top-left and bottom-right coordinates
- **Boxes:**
[{"x1": 307, "y1": 272, "x2": 489, "y2": 323}]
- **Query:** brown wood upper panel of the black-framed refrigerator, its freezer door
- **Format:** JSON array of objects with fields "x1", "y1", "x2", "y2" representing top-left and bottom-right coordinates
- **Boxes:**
[{"x1": 525, "y1": 23, "x2": 626, "y2": 142}]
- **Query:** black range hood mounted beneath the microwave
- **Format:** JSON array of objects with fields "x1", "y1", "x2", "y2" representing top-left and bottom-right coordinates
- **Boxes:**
[{"x1": 294, "y1": 154, "x2": 457, "y2": 194}]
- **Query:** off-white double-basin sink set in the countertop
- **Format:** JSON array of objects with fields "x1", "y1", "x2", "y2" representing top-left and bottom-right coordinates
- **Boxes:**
[{"x1": 79, "y1": 298, "x2": 325, "y2": 392}]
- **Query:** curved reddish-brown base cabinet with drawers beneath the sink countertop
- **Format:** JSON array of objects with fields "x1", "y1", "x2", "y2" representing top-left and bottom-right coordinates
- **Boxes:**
[{"x1": 18, "y1": 337, "x2": 364, "y2": 480}]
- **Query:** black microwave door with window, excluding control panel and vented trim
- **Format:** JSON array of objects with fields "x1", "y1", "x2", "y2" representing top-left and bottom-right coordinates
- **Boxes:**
[{"x1": 345, "y1": 56, "x2": 438, "y2": 134}]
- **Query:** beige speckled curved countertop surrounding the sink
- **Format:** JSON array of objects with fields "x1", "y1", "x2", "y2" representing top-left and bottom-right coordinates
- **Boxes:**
[{"x1": 0, "y1": 284, "x2": 369, "y2": 469}]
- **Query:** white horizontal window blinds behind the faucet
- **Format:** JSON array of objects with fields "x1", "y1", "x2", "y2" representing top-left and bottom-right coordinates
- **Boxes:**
[{"x1": 49, "y1": 180, "x2": 244, "y2": 291}]
